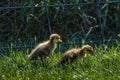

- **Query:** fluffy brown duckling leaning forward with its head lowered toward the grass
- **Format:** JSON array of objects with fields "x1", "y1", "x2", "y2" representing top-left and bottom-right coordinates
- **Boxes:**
[{"x1": 57, "y1": 45, "x2": 93, "y2": 66}]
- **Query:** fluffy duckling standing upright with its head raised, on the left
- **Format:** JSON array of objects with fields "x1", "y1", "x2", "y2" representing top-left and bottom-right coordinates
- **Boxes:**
[{"x1": 28, "y1": 34, "x2": 62, "y2": 60}]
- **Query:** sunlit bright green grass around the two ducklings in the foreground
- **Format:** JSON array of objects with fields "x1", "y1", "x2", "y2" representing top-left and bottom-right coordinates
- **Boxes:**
[{"x1": 0, "y1": 44, "x2": 120, "y2": 80}]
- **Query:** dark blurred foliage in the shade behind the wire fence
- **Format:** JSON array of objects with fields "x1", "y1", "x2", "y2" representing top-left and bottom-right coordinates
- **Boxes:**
[{"x1": 0, "y1": 0, "x2": 120, "y2": 42}]
